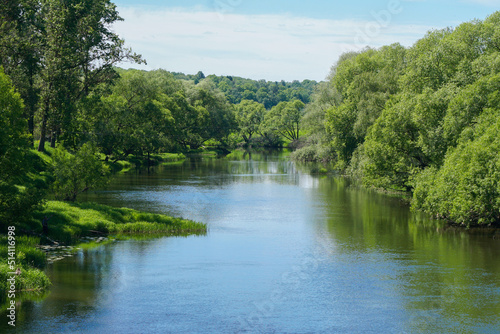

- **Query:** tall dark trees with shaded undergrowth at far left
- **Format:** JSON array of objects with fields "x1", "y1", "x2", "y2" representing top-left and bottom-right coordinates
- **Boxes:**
[{"x1": 0, "y1": 0, "x2": 143, "y2": 227}]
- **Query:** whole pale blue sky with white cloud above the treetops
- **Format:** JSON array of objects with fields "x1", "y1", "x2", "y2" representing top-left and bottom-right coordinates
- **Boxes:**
[{"x1": 113, "y1": 0, "x2": 500, "y2": 81}]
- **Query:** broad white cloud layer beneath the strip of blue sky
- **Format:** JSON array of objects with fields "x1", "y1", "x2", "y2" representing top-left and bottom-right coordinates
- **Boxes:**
[{"x1": 114, "y1": 8, "x2": 429, "y2": 81}]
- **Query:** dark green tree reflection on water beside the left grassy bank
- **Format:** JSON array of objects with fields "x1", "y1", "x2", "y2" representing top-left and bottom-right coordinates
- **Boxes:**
[{"x1": 5, "y1": 238, "x2": 172, "y2": 332}]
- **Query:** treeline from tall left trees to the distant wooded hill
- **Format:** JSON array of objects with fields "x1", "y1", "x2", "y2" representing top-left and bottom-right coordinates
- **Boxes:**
[{"x1": 0, "y1": 0, "x2": 315, "y2": 226}]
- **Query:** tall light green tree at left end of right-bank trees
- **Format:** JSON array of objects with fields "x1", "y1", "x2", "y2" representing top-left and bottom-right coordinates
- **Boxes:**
[{"x1": 326, "y1": 44, "x2": 406, "y2": 168}]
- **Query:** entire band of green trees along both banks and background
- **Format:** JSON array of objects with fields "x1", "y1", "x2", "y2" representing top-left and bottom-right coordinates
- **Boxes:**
[{"x1": 0, "y1": 0, "x2": 500, "y2": 231}]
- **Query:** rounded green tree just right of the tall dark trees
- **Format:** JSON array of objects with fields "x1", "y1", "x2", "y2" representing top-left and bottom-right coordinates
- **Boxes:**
[{"x1": 95, "y1": 70, "x2": 176, "y2": 158}]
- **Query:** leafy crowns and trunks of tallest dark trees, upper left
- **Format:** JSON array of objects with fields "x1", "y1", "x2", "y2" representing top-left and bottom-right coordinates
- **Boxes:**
[{"x1": 0, "y1": 0, "x2": 143, "y2": 151}]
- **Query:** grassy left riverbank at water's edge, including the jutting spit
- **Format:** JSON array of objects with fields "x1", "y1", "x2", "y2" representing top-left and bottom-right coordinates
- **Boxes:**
[{"x1": 0, "y1": 201, "x2": 207, "y2": 304}]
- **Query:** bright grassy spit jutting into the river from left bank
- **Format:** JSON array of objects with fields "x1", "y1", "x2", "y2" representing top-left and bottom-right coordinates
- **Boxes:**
[{"x1": 26, "y1": 201, "x2": 207, "y2": 244}]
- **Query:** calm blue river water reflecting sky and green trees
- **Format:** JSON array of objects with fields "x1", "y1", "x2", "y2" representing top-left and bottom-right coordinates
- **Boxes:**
[{"x1": 2, "y1": 154, "x2": 500, "y2": 333}]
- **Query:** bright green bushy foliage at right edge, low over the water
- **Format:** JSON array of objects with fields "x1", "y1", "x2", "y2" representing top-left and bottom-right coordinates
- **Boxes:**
[{"x1": 413, "y1": 109, "x2": 500, "y2": 226}]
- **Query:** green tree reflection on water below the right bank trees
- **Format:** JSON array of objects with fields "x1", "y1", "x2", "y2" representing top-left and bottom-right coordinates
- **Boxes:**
[{"x1": 308, "y1": 178, "x2": 500, "y2": 333}]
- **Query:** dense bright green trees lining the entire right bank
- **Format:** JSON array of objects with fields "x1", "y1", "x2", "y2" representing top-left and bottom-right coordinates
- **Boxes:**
[{"x1": 295, "y1": 12, "x2": 500, "y2": 225}]
